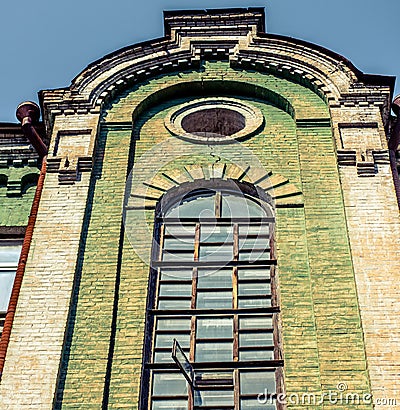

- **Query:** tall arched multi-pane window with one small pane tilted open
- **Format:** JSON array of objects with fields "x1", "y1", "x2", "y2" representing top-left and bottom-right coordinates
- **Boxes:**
[{"x1": 141, "y1": 183, "x2": 283, "y2": 410}]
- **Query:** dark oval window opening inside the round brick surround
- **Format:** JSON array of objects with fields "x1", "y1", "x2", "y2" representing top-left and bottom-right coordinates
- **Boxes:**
[{"x1": 181, "y1": 108, "x2": 246, "y2": 137}]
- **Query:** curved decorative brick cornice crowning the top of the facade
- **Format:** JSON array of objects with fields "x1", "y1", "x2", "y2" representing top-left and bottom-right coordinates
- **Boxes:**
[{"x1": 41, "y1": 9, "x2": 394, "y2": 131}]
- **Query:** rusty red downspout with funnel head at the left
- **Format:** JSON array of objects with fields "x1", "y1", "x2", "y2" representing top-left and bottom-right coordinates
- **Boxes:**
[{"x1": 0, "y1": 102, "x2": 47, "y2": 380}]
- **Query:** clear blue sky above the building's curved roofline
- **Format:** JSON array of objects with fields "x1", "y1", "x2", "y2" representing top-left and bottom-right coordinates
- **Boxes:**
[{"x1": 0, "y1": 0, "x2": 400, "y2": 122}]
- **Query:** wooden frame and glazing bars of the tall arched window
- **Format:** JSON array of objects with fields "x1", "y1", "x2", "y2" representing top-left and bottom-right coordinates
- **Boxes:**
[{"x1": 141, "y1": 181, "x2": 283, "y2": 410}]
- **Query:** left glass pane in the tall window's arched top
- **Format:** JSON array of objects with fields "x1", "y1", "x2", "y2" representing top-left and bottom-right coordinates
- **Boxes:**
[{"x1": 165, "y1": 194, "x2": 215, "y2": 218}]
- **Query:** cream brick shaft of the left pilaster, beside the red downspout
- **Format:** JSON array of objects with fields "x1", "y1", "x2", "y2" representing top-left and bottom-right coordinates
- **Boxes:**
[{"x1": 0, "y1": 174, "x2": 89, "y2": 410}]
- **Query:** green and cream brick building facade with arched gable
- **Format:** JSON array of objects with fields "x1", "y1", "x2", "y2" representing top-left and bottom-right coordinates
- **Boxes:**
[{"x1": 0, "y1": 9, "x2": 400, "y2": 409}]
